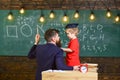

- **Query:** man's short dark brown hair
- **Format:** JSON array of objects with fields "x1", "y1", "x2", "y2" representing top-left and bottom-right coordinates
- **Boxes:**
[{"x1": 44, "y1": 29, "x2": 59, "y2": 42}]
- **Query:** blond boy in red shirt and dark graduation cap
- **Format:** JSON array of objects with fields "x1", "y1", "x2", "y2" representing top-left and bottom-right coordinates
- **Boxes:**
[{"x1": 61, "y1": 23, "x2": 80, "y2": 66}]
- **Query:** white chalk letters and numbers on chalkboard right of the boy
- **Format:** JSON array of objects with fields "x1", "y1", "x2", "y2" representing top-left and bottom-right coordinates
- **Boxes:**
[{"x1": 80, "y1": 24, "x2": 107, "y2": 53}]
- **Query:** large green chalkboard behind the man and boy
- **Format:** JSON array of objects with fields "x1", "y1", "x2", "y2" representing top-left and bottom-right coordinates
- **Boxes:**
[{"x1": 0, "y1": 10, "x2": 120, "y2": 57}]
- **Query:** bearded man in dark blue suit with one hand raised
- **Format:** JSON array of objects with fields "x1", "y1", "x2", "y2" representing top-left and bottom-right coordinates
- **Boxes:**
[{"x1": 28, "y1": 29, "x2": 79, "y2": 80}]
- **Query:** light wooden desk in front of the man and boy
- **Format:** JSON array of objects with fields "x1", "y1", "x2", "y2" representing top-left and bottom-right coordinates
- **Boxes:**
[{"x1": 42, "y1": 65, "x2": 98, "y2": 80}]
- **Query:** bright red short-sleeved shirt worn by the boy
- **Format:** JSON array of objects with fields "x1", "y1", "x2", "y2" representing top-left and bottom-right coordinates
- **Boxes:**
[{"x1": 66, "y1": 38, "x2": 80, "y2": 66}]
